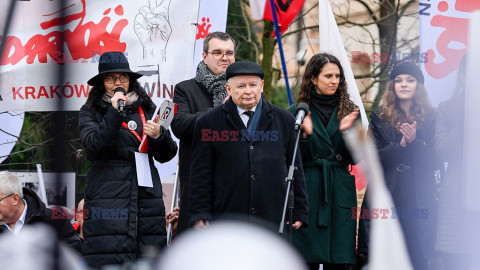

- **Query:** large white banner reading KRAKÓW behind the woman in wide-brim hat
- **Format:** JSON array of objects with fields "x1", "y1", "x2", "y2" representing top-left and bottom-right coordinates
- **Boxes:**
[{"x1": 0, "y1": 0, "x2": 199, "y2": 111}]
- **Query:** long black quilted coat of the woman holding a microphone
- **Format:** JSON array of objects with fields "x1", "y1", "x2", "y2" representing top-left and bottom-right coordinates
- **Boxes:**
[{"x1": 79, "y1": 99, "x2": 177, "y2": 267}]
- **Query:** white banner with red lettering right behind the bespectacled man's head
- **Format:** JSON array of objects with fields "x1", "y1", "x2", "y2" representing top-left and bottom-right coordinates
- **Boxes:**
[{"x1": 192, "y1": 0, "x2": 228, "y2": 77}]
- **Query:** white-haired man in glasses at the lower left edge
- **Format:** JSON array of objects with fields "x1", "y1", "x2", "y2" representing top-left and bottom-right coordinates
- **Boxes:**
[{"x1": 0, "y1": 171, "x2": 82, "y2": 253}]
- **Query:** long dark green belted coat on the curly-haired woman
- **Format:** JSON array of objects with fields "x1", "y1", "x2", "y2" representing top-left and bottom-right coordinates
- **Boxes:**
[{"x1": 291, "y1": 106, "x2": 357, "y2": 264}]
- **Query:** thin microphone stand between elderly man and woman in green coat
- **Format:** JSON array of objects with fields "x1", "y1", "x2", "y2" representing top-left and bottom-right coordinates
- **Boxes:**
[{"x1": 278, "y1": 125, "x2": 302, "y2": 243}]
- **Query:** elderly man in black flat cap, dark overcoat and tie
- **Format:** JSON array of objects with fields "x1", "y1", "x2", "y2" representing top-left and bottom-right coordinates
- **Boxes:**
[{"x1": 189, "y1": 61, "x2": 308, "y2": 232}]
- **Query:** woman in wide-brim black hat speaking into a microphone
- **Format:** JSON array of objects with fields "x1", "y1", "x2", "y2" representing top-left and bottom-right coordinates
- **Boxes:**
[{"x1": 79, "y1": 52, "x2": 177, "y2": 268}]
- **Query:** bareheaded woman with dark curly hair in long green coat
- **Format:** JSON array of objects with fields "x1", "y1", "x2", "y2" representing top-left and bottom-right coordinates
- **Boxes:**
[{"x1": 290, "y1": 53, "x2": 359, "y2": 269}]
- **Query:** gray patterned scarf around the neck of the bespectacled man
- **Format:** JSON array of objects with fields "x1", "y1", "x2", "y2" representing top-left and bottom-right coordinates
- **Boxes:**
[{"x1": 195, "y1": 61, "x2": 227, "y2": 107}]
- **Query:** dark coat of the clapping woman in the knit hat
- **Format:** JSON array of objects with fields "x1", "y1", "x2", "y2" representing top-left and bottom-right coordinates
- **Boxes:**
[{"x1": 359, "y1": 109, "x2": 443, "y2": 256}]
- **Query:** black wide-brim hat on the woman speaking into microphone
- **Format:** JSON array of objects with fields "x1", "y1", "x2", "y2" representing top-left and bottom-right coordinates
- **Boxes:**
[{"x1": 88, "y1": 52, "x2": 143, "y2": 86}]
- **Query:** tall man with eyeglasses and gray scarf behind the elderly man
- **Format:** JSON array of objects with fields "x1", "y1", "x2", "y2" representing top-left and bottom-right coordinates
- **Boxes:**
[{"x1": 172, "y1": 32, "x2": 235, "y2": 234}]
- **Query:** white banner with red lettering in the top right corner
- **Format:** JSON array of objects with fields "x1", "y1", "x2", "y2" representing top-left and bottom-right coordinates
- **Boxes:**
[{"x1": 419, "y1": 0, "x2": 480, "y2": 106}]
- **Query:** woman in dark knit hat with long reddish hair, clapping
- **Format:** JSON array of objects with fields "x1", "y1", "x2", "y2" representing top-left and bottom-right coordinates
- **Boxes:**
[{"x1": 359, "y1": 62, "x2": 441, "y2": 269}]
